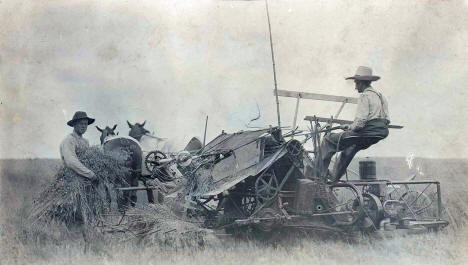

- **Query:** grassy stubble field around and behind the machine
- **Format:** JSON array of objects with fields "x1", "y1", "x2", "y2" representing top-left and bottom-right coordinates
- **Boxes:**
[{"x1": 0, "y1": 158, "x2": 468, "y2": 265}]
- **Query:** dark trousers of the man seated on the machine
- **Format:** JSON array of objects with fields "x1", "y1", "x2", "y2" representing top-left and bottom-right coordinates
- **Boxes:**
[{"x1": 319, "y1": 119, "x2": 388, "y2": 181}]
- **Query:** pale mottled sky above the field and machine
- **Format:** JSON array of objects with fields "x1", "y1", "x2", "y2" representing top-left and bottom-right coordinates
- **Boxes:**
[{"x1": 0, "y1": 0, "x2": 468, "y2": 158}]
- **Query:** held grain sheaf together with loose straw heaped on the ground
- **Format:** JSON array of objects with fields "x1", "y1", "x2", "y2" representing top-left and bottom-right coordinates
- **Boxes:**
[{"x1": 29, "y1": 144, "x2": 208, "y2": 248}]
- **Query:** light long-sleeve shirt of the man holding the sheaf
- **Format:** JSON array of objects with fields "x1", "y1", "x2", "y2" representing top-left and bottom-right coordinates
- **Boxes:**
[{"x1": 60, "y1": 132, "x2": 93, "y2": 178}]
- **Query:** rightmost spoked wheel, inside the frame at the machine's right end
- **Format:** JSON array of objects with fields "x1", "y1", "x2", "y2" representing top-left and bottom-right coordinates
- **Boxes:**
[{"x1": 400, "y1": 190, "x2": 434, "y2": 218}]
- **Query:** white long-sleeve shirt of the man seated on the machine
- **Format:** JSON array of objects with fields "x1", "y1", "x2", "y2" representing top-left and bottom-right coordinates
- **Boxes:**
[{"x1": 350, "y1": 87, "x2": 390, "y2": 131}]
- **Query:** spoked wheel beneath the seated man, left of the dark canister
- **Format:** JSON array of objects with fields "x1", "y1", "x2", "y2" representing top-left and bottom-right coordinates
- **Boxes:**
[{"x1": 331, "y1": 183, "x2": 364, "y2": 226}]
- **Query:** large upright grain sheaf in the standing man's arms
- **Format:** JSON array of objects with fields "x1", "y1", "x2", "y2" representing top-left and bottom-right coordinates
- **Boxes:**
[{"x1": 31, "y1": 146, "x2": 130, "y2": 226}]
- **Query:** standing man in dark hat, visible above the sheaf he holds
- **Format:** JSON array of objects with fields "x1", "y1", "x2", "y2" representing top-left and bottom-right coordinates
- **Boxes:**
[{"x1": 60, "y1": 111, "x2": 96, "y2": 181}]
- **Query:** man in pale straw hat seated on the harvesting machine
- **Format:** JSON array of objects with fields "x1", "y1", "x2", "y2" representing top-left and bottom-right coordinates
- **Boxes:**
[{"x1": 320, "y1": 66, "x2": 390, "y2": 181}]
